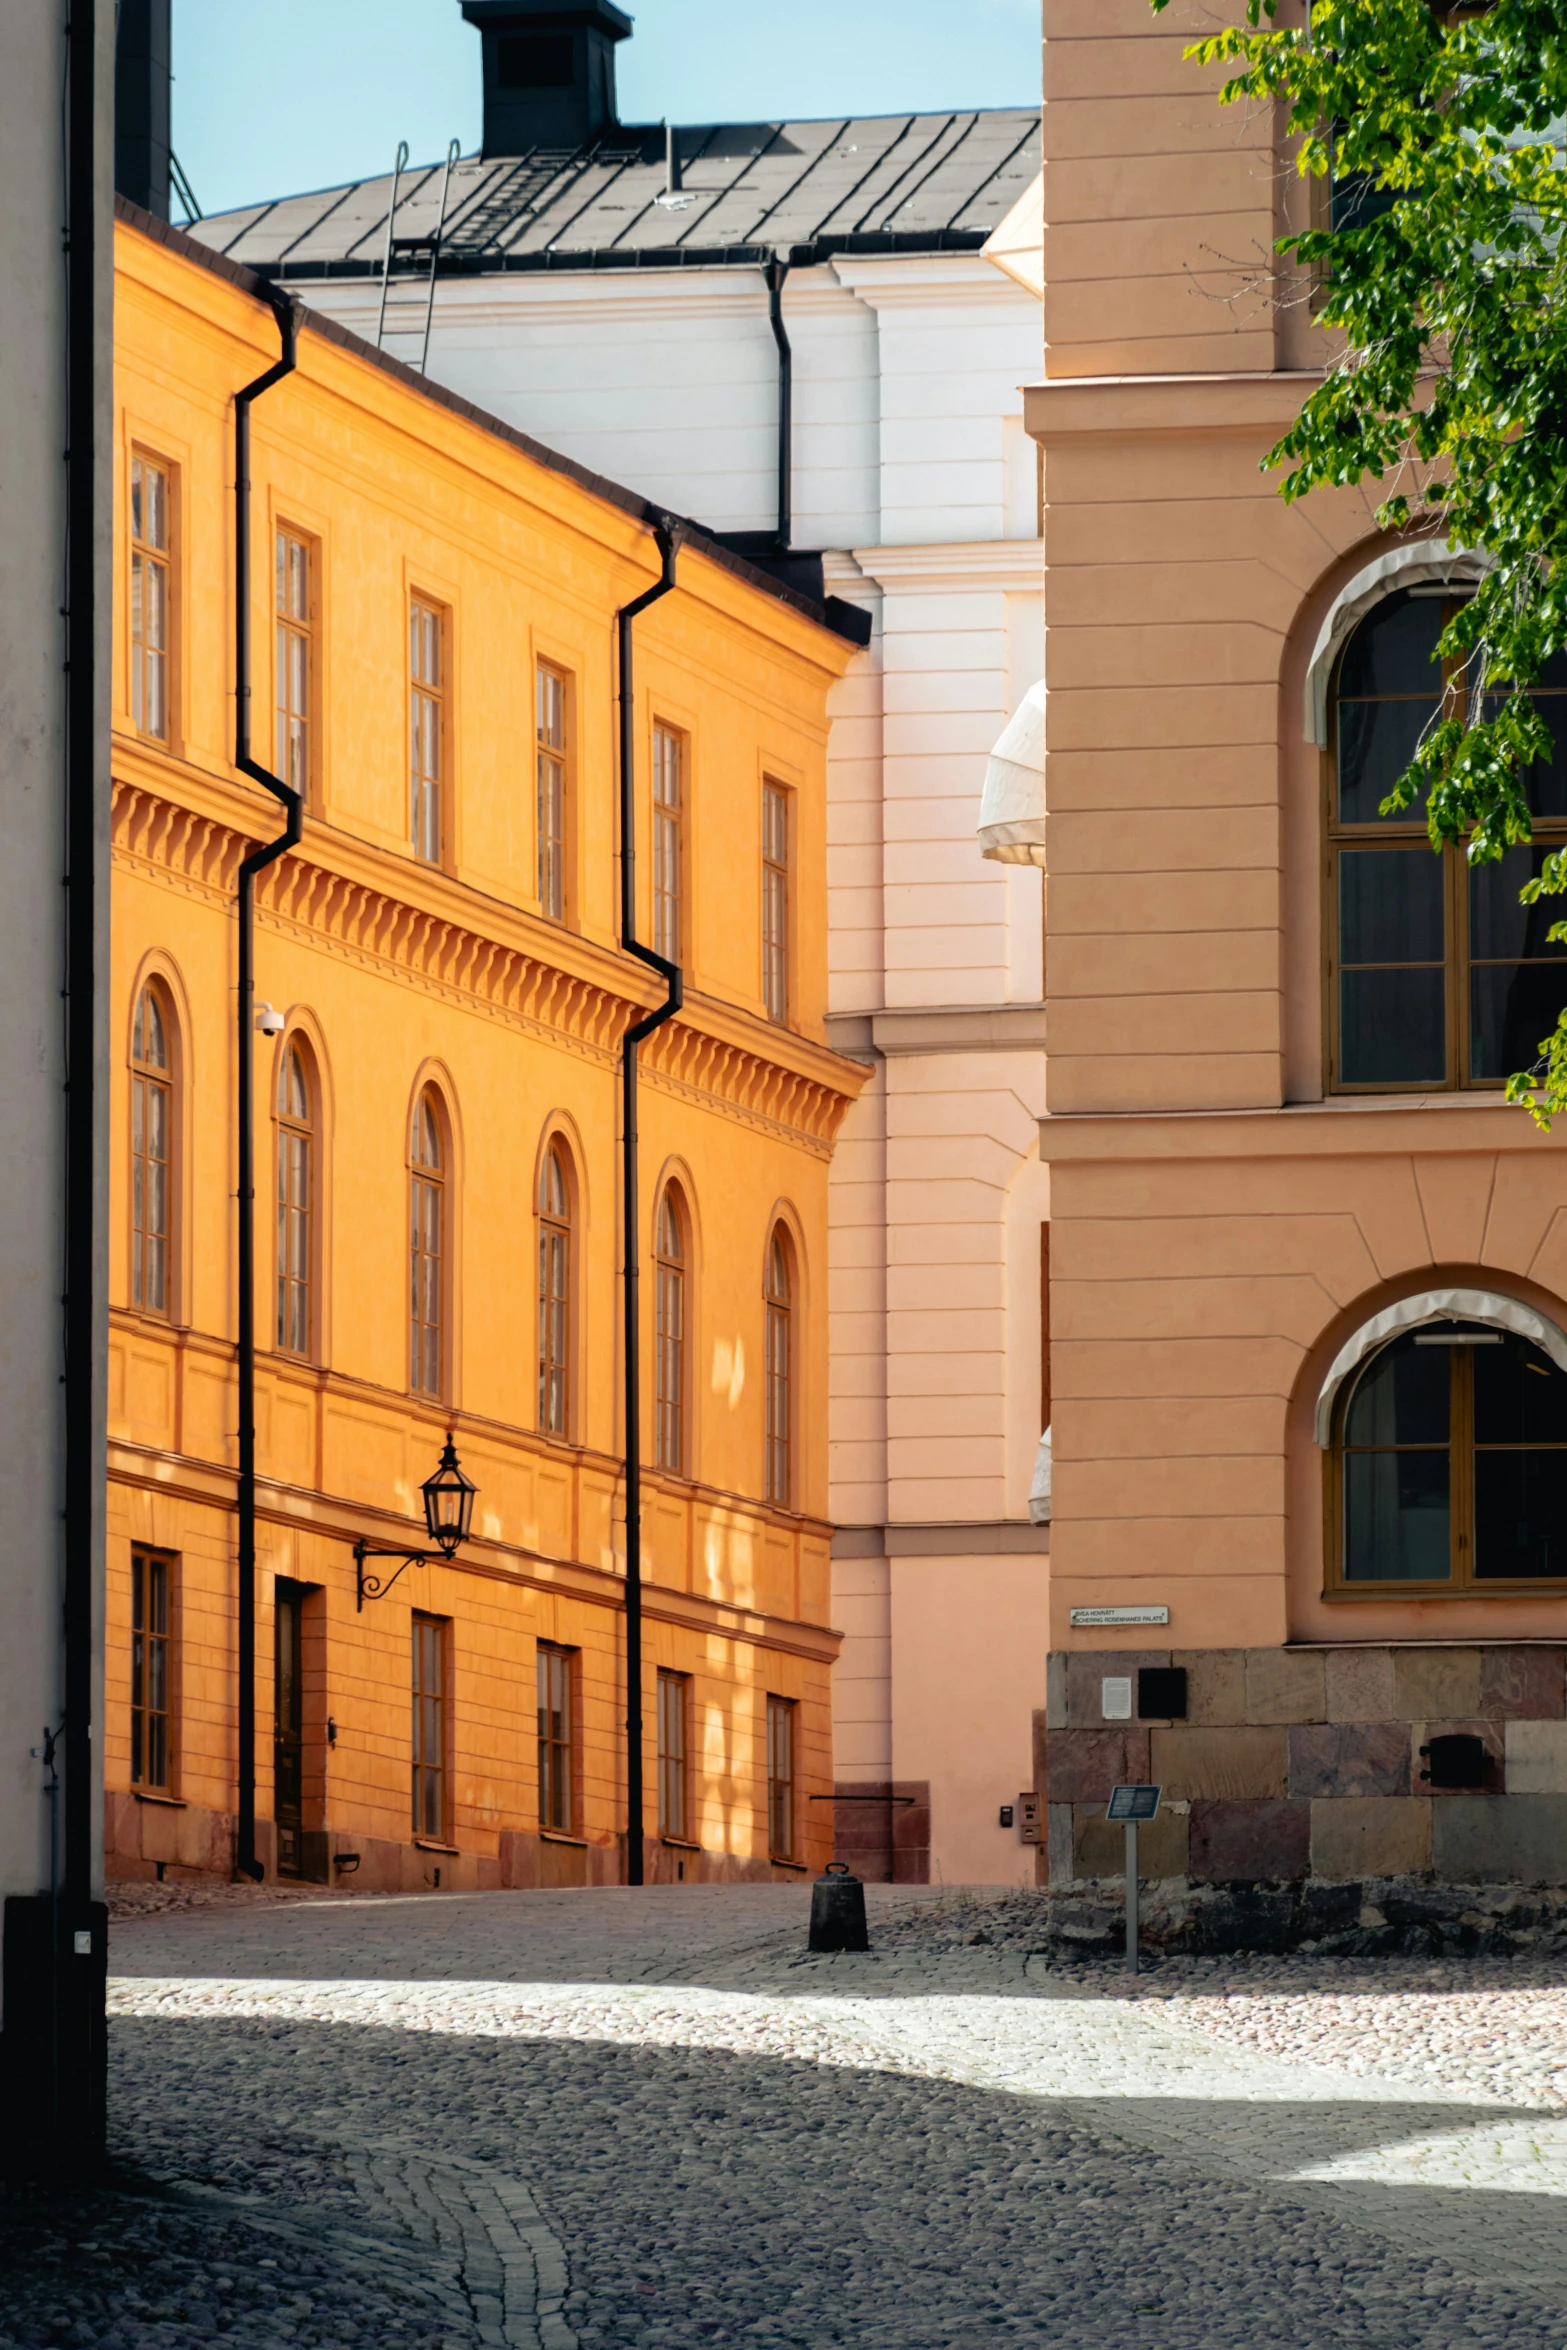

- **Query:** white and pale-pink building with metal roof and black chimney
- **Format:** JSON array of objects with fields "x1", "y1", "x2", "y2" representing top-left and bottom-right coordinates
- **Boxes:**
[{"x1": 195, "y1": 0, "x2": 1048, "y2": 1882}]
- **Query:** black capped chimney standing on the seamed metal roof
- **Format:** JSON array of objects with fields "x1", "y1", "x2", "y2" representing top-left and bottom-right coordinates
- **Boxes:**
[{"x1": 460, "y1": 0, "x2": 632, "y2": 157}]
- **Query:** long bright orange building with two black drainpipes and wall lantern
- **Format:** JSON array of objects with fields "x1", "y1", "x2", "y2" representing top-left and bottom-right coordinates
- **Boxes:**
[{"x1": 106, "y1": 207, "x2": 862, "y2": 1887}]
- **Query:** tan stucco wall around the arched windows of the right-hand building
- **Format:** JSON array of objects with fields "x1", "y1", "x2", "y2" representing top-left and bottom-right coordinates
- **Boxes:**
[{"x1": 1027, "y1": 0, "x2": 1567, "y2": 1875}]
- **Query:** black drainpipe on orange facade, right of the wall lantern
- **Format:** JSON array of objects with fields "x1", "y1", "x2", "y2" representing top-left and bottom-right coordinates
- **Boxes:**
[{"x1": 616, "y1": 517, "x2": 686, "y2": 1885}]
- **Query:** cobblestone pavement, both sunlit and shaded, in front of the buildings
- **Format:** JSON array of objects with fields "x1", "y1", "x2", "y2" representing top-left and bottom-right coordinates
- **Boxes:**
[{"x1": 0, "y1": 1887, "x2": 1567, "y2": 2350}]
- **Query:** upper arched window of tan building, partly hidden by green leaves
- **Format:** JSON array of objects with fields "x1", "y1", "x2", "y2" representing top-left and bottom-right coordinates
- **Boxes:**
[{"x1": 1327, "y1": 585, "x2": 1567, "y2": 1093}]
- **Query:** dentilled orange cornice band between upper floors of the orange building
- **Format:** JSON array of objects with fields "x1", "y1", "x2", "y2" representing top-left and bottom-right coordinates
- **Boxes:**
[{"x1": 113, "y1": 780, "x2": 865, "y2": 1159}]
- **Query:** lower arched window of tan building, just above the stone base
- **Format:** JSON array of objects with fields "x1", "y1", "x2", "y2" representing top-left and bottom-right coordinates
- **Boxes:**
[{"x1": 1330, "y1": 1321, "x2": 1567, "y2": 1593}]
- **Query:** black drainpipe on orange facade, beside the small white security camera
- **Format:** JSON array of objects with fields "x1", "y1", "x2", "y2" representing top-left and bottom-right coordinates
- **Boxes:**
[{"x1": 235, "y1": 294, "x2": 305, "y2": 1878}]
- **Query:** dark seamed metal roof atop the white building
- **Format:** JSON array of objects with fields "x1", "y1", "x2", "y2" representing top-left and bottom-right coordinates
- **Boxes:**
[{"x1": 190, "y1": 106, "x2": 1041, "y2": 280}]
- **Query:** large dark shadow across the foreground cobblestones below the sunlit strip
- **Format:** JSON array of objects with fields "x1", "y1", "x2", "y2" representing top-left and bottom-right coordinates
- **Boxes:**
[{"x1": 95, "y1": 2016, "x2": 1562, "y2": 2350}]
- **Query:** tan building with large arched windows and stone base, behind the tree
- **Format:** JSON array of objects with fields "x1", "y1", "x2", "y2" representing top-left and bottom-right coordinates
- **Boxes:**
[{"x1": 1027, "y1": 0, "x2": 1567, "y2": 1922}]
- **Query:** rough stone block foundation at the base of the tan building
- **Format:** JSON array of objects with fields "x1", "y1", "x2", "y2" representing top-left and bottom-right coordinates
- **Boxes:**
[{"x1": 1036, "y1": 1643, "x2": 1567, "y2": 1917}]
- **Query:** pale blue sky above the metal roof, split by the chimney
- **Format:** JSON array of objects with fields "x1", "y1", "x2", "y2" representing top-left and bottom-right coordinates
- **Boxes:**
[{"x1": 174, "y1": 0, "x2": 1041, "y2": 212}]
